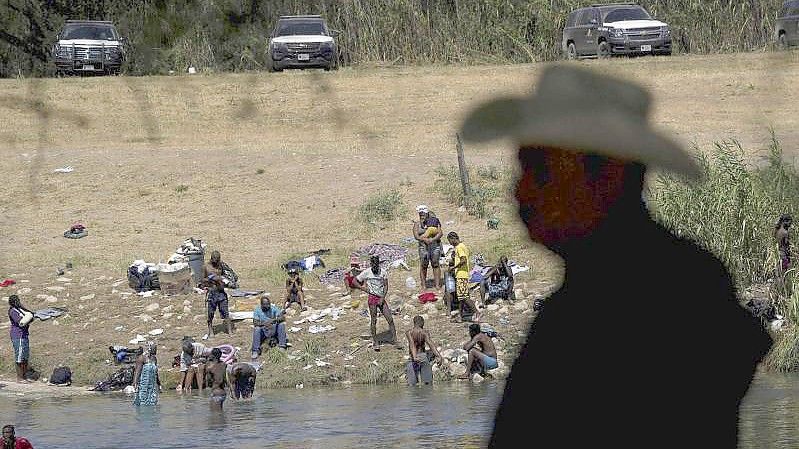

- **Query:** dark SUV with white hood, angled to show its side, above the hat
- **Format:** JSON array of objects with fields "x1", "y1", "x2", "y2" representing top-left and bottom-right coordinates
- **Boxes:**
[{"x1": 562, "y1": 3, "x2": 671, "y2": 59}]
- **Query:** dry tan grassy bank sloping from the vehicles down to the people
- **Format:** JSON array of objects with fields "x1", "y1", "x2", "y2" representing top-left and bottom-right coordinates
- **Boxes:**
[{"x1": 0, "y1": 52, "x2": 799, "y2": 384}]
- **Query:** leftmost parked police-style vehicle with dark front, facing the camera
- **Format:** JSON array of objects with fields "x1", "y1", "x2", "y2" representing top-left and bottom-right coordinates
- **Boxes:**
[{"x1": 53, "y1": 20, "x2": 125, "y2": 74}]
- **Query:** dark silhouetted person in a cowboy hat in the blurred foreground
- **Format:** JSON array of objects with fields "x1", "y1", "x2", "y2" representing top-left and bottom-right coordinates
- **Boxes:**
[{"x1": 461, "y1": 66, "x2": 771, "y2": 448}]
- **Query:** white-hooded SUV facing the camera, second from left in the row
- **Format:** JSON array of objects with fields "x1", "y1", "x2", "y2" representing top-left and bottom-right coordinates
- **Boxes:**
[{"x1": 266, "y1": 16, "x2": 338, "y2": 72}]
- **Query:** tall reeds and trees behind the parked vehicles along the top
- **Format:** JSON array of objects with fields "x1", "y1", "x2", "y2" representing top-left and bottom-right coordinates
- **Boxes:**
[{"x1": 0, "y1": 0, "x2": 781, "y2": 77}]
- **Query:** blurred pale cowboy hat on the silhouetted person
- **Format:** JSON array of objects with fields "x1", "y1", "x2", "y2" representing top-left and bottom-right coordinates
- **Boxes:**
[{"x1": 460, "y1": 65, "x2": 702, "y2": 179}]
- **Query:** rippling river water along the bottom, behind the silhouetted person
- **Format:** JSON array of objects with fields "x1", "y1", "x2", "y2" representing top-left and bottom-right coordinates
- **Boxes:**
[{"x1": 0, "y1": 374, "x2": 799, "y2": 449}]
